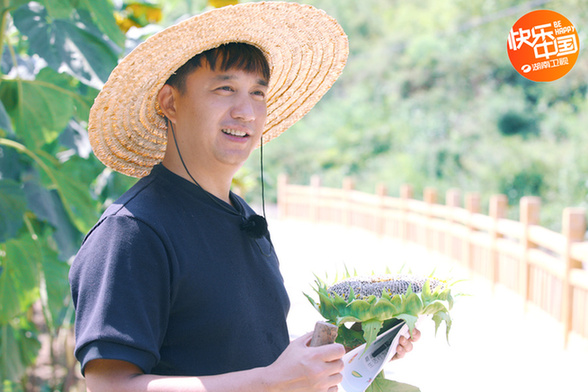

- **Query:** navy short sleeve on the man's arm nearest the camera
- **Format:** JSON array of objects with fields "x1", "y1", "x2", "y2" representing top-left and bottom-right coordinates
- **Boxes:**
[{"x1": 69, "y1": 215, "x2": 172, "y2": 373}]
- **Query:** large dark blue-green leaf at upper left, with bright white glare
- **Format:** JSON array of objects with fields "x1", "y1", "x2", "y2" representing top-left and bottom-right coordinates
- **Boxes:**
[{"x1": 13, "y1": 2, "x2": 120, "y2": 89}]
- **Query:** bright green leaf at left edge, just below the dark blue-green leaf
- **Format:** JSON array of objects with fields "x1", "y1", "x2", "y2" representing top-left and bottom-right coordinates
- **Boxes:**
[{"x1": 0, "y1": 68, "x2": 76, "y2": 148}]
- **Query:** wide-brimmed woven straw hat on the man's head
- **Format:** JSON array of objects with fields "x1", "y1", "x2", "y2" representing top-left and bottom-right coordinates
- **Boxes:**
[{"x1": 88, "y1": 2, "x2": 349, "y2": 177}]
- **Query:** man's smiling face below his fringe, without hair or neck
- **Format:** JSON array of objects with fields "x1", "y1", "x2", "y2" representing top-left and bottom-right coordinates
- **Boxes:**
[{"x1": 169, "y1": 64, "x2": 268, "y2": 171}]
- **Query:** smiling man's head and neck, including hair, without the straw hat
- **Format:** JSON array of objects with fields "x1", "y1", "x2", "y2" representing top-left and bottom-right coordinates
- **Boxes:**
[{"x1": 159, "y1": 43, "x2": 270, "y2": 203}]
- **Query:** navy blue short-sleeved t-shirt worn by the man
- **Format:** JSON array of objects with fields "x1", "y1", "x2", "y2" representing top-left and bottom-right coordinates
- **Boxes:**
[{"x1": 70, "y1": 165, "x2": 290, "y2": 376}]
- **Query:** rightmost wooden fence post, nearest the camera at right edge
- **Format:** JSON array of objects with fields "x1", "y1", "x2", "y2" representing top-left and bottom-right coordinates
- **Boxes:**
[{"x1": 561, "y1": 207, "x2": 586, "y2": 347}]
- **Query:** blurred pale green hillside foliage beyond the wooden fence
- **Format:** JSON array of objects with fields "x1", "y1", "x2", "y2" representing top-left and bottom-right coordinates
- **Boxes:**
[{"x1": 242, "y1": 0, "x2": 588, "y2": 229}]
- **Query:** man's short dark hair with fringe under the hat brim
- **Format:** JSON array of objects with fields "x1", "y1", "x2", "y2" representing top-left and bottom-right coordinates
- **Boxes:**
[{"x1": 165, "y1": 42, "x2": 270, "y2": 94}]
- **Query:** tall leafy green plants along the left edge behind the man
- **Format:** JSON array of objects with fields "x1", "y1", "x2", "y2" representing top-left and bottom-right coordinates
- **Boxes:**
[{"x1": 0, "y1": 0, "x2": 140, "y2": 391}]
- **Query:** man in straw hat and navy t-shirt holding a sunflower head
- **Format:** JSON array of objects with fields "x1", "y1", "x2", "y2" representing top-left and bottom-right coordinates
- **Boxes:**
[{"x1": 70, "y1": 3, "x2": 412, "y2": 392}]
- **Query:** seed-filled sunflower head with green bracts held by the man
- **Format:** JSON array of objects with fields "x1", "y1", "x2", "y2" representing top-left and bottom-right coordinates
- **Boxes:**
[{"x1": 305, "y1": 274, "x2": 453, "y2": 349}]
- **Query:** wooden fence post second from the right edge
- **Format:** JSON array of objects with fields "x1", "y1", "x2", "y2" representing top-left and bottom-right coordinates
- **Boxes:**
[{"x1": 519, "y1": 196, "x2": 541, "y2": 310}]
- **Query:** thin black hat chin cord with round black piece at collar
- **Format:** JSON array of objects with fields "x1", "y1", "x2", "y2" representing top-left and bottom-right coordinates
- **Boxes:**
[{"x1": 166, "y1": 117, "x2": 269, "y2": 239}]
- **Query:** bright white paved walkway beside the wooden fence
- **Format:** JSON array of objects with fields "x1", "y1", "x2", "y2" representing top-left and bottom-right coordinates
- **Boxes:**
[{"x1": 269, "y1": 219, "x2": 588, "y2": 392}]
